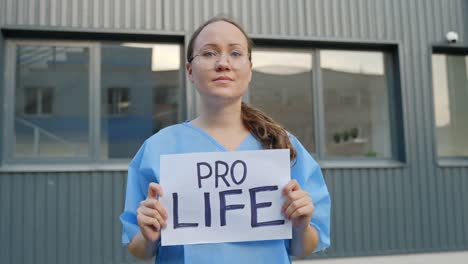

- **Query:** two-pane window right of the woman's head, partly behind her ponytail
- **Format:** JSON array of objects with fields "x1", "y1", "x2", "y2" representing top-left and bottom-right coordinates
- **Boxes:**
[{"x1": 248, "y1": 48, "x2": 400, "y2": 159}]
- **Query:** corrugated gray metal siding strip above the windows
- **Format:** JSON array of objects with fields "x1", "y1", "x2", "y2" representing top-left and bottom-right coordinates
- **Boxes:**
[{"x1": 1, "y1": 0, "x2": 466, "y2": 41}]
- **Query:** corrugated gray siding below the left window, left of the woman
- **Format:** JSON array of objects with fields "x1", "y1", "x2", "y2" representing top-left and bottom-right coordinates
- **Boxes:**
[{"x1": 0, "y1": 172, "x2": 150, "y2": 264}]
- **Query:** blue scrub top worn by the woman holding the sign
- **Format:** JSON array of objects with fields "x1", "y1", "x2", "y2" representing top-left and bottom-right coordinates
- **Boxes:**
[{"x1": 120, "y1": 122, "x2": 330, "y2": 264}]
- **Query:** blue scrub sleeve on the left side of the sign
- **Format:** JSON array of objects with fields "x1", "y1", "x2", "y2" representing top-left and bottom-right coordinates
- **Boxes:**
[{"x1": 120, "y1": 143, "x2": 157, "y2": 245}]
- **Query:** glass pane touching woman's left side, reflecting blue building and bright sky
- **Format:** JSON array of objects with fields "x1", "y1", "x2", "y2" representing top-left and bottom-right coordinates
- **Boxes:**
[{"x1": 100, "y1": 43, "x2": 181, "y2": 159}]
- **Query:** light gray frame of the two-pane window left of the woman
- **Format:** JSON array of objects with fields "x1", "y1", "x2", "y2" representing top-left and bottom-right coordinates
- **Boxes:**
[{"x1": 0, "y1": 37, "x2": 188, "y2": 166}]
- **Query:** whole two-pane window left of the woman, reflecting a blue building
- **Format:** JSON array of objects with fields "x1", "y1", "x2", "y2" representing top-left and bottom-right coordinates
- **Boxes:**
[{"x1": 4, "y1": 40, "x2": 183, "y2": 162}]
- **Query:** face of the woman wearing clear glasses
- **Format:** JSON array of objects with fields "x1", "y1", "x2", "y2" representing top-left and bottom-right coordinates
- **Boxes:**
[{"x1": 186, "y1": 21, "x2": 252, "y2": 102}]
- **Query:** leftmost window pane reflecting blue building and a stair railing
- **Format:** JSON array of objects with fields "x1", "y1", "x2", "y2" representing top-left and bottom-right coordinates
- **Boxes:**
[{"x1": 14, "y1": 45, "x2": 89, "y2": 157}]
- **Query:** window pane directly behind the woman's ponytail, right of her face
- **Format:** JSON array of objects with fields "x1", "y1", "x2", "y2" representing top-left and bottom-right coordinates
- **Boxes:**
[{"x1": 248, "y1": 49, "x2": 316, "y2": 152}]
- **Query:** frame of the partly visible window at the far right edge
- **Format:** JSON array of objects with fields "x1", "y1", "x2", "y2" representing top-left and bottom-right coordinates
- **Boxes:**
[{"x1": 428, "y1": 44, "x2": 468, "y2": 168}]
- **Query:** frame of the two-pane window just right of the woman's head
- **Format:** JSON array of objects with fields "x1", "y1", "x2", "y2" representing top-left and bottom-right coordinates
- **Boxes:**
[{"x1": 253, "y1": 39, "x2": 407, "y2": 168}]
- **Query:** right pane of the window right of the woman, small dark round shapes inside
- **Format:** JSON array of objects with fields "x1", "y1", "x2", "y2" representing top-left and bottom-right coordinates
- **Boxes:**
[{"x1": 320, "y1": 50, "x2": 391, "y2": 157}]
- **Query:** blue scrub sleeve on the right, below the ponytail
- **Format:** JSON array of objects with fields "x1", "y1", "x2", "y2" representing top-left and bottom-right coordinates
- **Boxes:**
[{"x1": 290, "y1": 135, "x2": 331, "y2": 252}]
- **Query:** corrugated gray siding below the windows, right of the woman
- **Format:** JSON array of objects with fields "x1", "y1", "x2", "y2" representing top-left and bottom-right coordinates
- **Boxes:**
[{"x1": 324, "y1": 168, "x2": 468, "y2": 256}]
